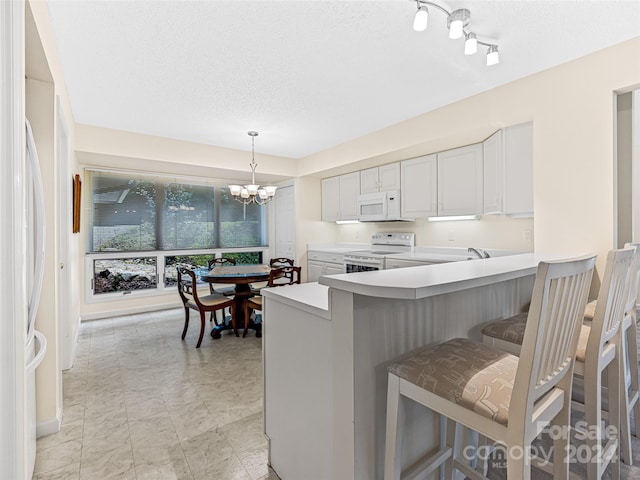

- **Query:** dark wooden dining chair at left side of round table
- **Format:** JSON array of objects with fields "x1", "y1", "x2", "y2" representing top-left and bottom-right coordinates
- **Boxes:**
[{"x1": 177, "y1": 267, "x2": 235, "y2": 348}]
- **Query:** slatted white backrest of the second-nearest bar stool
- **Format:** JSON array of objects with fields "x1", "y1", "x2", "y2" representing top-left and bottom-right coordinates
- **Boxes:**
[{"x1": 586, "y1": 247, "x2": 637, "y2": 359}]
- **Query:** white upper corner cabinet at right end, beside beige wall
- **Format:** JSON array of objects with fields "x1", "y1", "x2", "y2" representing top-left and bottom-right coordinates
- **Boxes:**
[{"x1": 483, "y1": 122, "x2": 533, "y2": 217}]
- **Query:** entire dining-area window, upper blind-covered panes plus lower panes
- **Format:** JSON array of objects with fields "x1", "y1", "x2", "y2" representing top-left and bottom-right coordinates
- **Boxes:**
[{"x1": 86, "y1": 170, "x2": 267, "y2": 299}]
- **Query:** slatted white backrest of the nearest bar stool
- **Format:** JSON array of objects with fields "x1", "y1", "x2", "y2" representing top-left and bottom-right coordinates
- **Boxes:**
[{"x1": 509, "y1": 255, "x2": 595, "y2": 422}]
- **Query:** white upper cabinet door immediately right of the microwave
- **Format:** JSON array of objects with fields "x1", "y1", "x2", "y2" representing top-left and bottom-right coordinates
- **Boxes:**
[{"x1": 400, "y1": 155, "x2": 438, "y2": 218}]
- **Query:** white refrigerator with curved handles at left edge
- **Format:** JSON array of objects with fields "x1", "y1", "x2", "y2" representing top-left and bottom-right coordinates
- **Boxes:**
[{"x1": 25, "y1": 120, "x2": 47, "y2": 478}]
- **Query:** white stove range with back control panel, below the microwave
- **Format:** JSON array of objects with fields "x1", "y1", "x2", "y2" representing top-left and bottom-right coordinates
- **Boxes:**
[{"x1": 343, "y1": 232, "x2": 416, "y2": 273}]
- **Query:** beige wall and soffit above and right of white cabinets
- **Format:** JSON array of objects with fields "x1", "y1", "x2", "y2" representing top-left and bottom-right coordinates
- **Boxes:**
[{"x1": 300, "y1": 37, "x2": 640, "y2": 278}]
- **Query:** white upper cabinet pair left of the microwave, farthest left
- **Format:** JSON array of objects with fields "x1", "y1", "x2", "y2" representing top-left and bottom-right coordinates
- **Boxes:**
[{"x1": 322, "y1": 172, "x2": 360, "y2": 222}]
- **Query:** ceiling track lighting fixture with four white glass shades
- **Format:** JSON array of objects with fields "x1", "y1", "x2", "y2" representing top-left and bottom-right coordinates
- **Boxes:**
[{"x1": 410, "y1": 0, "x2": 500, "y2": 66}]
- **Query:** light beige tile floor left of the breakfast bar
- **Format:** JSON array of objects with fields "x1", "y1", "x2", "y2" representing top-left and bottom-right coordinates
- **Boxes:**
[{"x1": 33, "y1": 309, "x2": 278, "y2": 480}]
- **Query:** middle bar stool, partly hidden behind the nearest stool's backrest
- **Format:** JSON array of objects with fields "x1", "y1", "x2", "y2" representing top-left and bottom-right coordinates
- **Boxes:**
[{"x1": 482, "y1": 248, "x2": 636, "y2": 480}]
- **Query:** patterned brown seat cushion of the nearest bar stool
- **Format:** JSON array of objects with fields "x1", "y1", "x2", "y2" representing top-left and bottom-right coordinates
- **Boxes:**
[{"x1": 388, "y1": 338, "x2": 518, "y2": 425}]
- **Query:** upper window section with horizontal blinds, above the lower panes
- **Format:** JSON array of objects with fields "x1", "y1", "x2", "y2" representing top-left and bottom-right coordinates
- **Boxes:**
[{"x1": 88, "y1": 171, "x2": 267, "y2": 252}]
